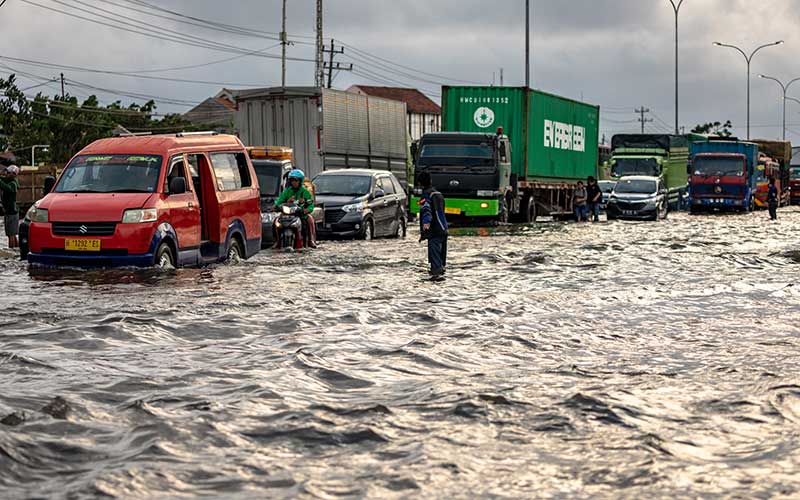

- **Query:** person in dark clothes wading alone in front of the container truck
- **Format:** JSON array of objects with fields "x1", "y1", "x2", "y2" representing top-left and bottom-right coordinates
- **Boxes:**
[{"x1": 417, "y1": 172, "x2": 448, "y2": 280}]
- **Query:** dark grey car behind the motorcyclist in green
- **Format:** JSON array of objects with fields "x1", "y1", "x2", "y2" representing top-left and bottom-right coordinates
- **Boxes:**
[{"x1": 314, "y1": 169, "x2": 408, "y2": 240}]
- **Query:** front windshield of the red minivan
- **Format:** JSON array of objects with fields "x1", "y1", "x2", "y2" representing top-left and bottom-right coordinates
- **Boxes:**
[{"x1": 54, "y1": 155, "x2": 162, "y2": 193}]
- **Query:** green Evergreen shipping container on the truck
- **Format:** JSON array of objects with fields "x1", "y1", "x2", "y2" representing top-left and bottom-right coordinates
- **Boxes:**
[{"x1": 442, "y1": 87, "x2": 600, "y2": 182}]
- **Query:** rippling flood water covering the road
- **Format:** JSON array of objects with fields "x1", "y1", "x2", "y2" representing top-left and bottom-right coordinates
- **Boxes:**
[{"x1": 0, "y1": 208, "x2": 800, "y2": 499}]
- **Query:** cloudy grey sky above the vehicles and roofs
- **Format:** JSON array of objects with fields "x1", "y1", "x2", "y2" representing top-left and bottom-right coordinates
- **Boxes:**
[{"x1": 0, "y1": 0, "x2": 800, "y2": 142}]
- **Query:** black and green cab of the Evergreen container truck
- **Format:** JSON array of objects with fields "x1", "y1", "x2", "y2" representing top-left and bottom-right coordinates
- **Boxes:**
[{"x1": 411, "y1": 129, "x2": 511, "y2": 220}]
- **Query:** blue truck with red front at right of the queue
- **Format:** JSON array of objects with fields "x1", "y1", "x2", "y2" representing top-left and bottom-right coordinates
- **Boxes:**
[{"x1": 687, "y1": 138, "x2": 759, "y2": 213}]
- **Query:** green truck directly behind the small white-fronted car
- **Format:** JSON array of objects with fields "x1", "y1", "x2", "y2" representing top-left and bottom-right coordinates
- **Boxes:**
[{"x1": 603, "y1": 134, "x2": 708, "y2": 210}]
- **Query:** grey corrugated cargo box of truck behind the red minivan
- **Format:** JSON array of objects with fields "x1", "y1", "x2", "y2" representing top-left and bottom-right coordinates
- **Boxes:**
[{"x1": 229, "y1": 87, "x2": 408, "y2": 183}]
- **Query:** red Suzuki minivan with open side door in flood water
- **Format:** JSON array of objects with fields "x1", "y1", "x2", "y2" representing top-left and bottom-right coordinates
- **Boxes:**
[{"x1": 26, "y1": 132, "x2": 261, "y2": 267}]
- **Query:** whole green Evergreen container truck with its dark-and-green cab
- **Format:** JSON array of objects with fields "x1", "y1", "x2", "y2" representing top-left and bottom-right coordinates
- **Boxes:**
[{"x1": 411, "y1": 87, "x2": 600, "y2": 222}]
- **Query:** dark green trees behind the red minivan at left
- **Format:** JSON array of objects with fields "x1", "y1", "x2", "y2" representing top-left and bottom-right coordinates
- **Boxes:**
[{"x1": 0, "y1": 75, "x2": 196, "y2": 164}]
